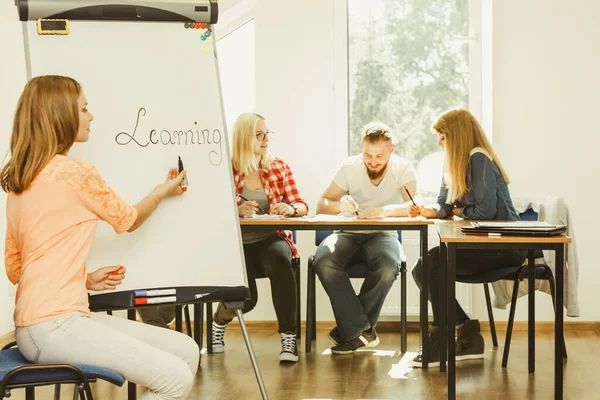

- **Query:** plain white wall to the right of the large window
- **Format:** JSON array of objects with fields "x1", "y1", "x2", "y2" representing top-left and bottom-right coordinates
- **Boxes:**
[{"x1": 473, "y1": 0, "x2": 600, "y2": 321}]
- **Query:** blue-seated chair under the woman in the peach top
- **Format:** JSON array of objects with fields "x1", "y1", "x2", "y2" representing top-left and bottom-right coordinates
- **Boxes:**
[{"x1": 0, "y1": 342, "x2": 125, "y2": 400}]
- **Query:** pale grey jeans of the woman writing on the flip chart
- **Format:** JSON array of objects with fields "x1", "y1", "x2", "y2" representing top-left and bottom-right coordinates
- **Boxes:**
[{"x1": 16, "y1": 313, "x2": 200, "y2": 400}]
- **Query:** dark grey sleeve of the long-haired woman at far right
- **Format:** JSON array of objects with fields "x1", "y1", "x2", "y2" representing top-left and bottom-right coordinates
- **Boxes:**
[{"x1": 460, "y1": 153, "x2": 498, "y2": 220}]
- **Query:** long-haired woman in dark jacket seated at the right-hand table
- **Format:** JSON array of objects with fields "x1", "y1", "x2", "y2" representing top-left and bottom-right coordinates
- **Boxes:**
[{"x1": 409, "y1": 109, "x2": 525, "y2": 367}]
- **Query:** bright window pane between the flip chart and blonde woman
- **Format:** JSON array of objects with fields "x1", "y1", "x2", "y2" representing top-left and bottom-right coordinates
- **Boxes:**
[{"x1": 217, "y1": 20, "x2": 256, "y2": 135}]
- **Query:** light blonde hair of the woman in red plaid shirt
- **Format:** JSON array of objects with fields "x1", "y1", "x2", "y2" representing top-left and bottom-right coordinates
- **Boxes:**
[{"x1": 231, "y1": 113, "x2": 273, "y2": 174}]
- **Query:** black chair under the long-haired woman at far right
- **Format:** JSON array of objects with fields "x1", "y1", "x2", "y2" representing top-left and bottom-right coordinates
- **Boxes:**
[{"x1": 456, "y1": 209, "x2": 567, "y2": 368}]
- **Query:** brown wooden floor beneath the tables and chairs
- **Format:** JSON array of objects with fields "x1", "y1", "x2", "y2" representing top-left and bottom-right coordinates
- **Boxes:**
[{"x1": 1, "y1": 326, "x2": 600, "y2": 400}]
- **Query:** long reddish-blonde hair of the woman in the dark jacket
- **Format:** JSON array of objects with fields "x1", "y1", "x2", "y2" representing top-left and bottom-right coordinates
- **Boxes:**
[{"x1": 431, "y1": 109, "x2": 510, "y2": 204}]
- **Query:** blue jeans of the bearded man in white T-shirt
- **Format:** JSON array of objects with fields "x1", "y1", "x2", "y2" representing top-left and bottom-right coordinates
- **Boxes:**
[{"x1": 314, "y1": 232, "x2": 402, "y2": 341}]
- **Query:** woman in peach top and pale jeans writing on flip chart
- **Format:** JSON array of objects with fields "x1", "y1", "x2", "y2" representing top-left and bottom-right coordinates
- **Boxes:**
[{"x1": 0, "y1": 76, "x2": 199, "y2": 400}]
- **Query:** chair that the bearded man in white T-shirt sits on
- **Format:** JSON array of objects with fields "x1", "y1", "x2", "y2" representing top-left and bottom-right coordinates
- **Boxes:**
[{"x1": 304, "y1": 231, "x2": 407, "y2": 353}]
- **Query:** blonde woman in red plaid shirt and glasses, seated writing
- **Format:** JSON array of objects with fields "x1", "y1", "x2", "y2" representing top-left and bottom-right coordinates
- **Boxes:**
[{"x1": 212, "y1": 114, "x2": 308, "y2": 362}]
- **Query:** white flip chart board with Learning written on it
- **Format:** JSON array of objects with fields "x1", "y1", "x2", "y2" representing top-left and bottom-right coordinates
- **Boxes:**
[{"x1": 24, "y1": 21, "x2": 248, "y2": 300}]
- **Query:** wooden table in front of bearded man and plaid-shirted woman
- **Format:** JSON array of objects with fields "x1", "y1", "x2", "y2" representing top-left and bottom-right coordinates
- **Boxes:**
[{"x1": 240, "y1": 218, "x2": 434, "y2": 368}]
